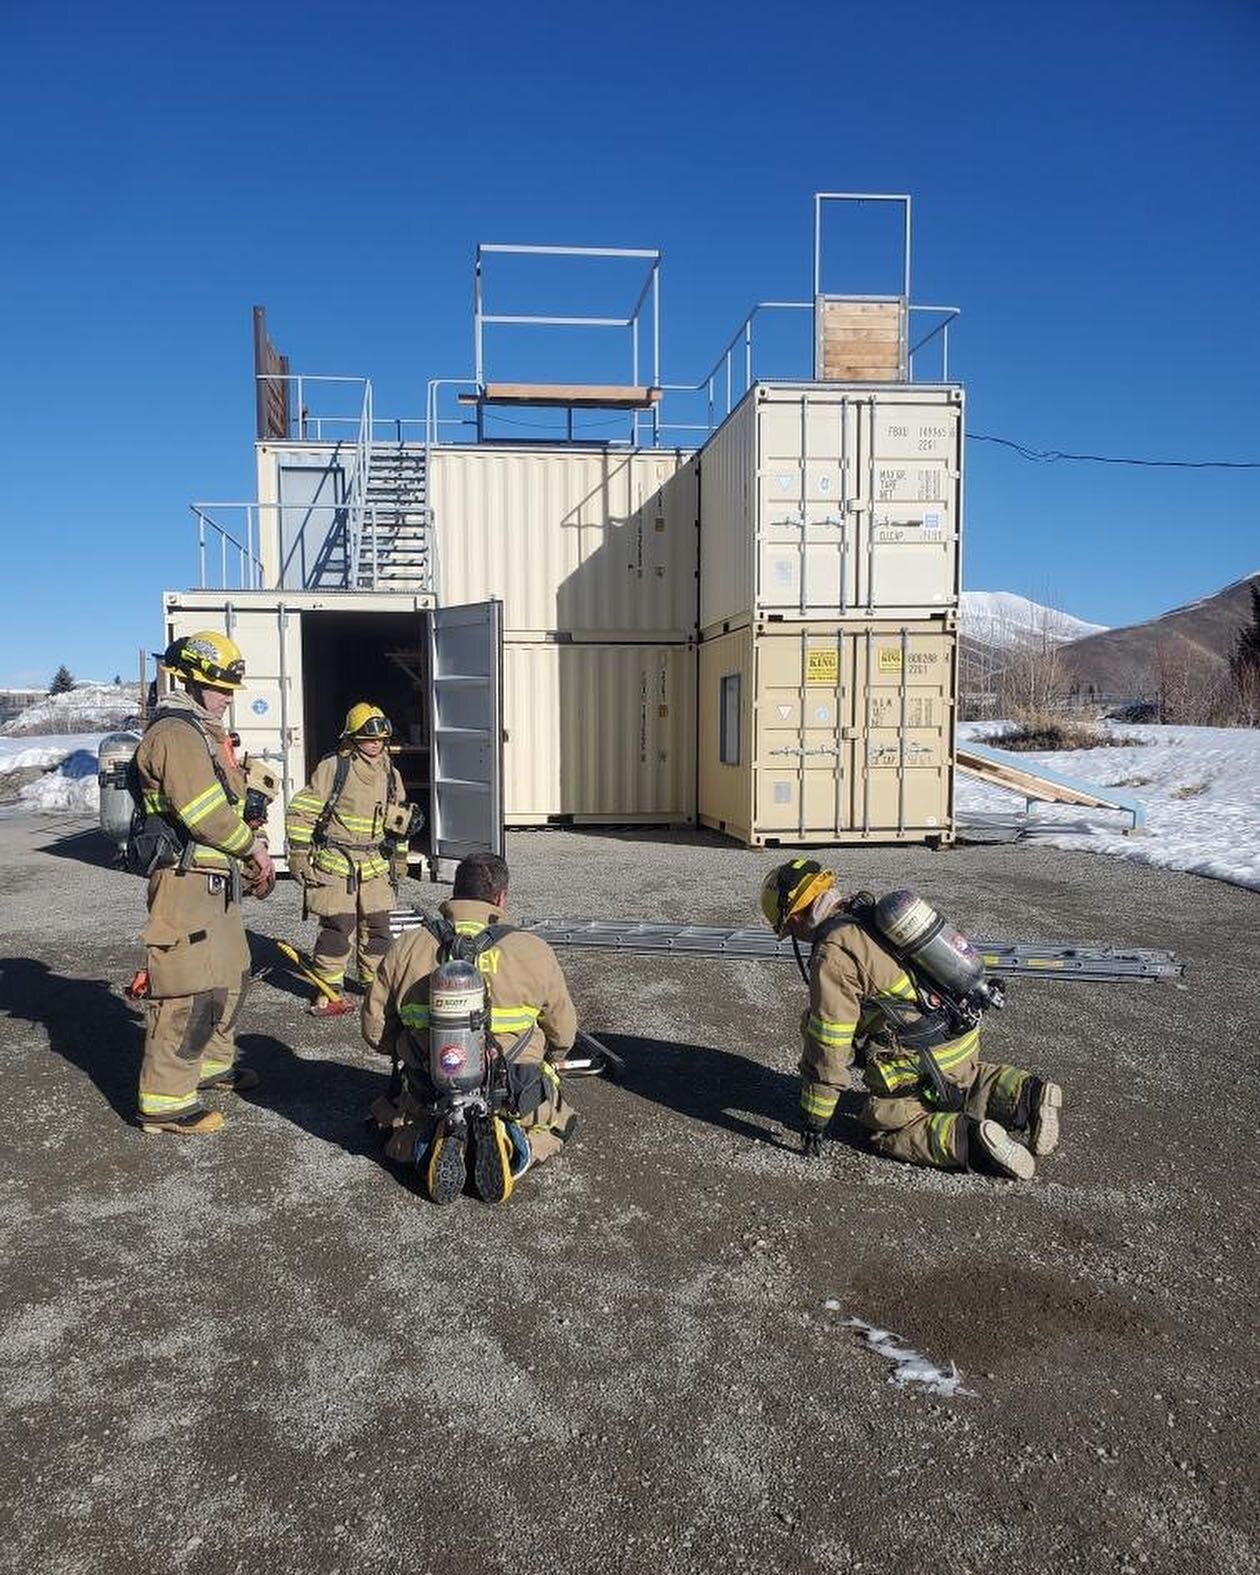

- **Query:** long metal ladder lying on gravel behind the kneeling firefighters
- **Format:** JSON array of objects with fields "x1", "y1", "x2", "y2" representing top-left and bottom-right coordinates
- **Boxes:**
[{"x1": 389, "y1": 907, "x2": 1184, "y2": 984}]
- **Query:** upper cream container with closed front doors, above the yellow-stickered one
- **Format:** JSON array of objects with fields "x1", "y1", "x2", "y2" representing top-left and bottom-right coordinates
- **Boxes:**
[{"x1": 699, "y1": 383, "x2": 962, "y2": 632}]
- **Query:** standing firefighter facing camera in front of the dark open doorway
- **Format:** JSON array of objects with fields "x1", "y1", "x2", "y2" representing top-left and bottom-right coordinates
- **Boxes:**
[{"x1": 285, "y1": 701, "x2": 413, "y2": 1017}]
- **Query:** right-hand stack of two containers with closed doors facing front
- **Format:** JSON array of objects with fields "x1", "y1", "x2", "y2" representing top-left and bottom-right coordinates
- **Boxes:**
[{"x1": 698, "y1": 384, "x2": 962, "y2": 844}]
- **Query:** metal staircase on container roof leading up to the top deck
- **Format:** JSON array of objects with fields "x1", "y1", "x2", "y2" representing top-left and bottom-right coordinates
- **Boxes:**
[{"x1": 350, "y1": 443, "x2": 433, "y2": 591}]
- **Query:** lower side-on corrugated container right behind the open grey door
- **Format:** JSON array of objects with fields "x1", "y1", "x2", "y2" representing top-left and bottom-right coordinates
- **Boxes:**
[{"x1": 502, "y1": 635, "x2": 696, "y2": 825}]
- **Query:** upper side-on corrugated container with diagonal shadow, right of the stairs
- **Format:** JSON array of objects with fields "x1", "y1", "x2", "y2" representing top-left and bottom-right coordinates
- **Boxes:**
[{"x1": 428, "y1": 446, "x2": 698, "y2": 641}]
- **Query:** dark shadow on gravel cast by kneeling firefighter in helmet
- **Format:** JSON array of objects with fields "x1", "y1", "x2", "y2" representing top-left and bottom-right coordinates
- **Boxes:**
[{"x1": 595, "y1": 1033, "x2": 868, "y2": 1153}]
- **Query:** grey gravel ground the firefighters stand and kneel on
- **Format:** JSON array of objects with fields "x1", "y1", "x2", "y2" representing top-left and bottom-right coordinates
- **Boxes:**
[{"x1": 0, "y1": 816, "x2": 1260, "y2": 1575}]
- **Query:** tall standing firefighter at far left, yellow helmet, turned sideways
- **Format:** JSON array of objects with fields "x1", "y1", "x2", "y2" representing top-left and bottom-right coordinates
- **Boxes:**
[{"x1": 128, "y1": 630, "x2": 276, "y2": 1134}]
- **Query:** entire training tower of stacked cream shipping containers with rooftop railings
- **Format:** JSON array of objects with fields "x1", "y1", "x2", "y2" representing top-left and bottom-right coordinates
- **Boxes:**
[{"x1": 172, "y1": 192, "x2": 962, "y2": 866}]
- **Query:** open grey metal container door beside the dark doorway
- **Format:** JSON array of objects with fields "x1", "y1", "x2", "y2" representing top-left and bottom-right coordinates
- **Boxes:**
[{"x1": 424, "y1": 602, "x2": 502, "y2": 880}]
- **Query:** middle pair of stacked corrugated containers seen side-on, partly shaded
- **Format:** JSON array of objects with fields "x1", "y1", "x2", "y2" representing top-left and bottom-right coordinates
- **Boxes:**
[{"x1": 428, "y1": 446, "x2": 698, "y2": 825}]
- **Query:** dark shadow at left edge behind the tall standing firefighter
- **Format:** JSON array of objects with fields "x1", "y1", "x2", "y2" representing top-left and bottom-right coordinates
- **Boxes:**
[{"x1": 0, "y1": 958, "x2": 145, "y2": 1121}]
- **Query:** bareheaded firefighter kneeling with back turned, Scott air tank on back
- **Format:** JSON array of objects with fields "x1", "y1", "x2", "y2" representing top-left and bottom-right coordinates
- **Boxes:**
[{"x1": 362, "y1": 854, "x2": 578, "y2": 1203}]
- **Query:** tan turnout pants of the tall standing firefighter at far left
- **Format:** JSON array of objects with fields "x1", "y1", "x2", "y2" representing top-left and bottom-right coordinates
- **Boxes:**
[{"x1": 139, "y1": 869, "x2": 249, "y2": 1117}]
